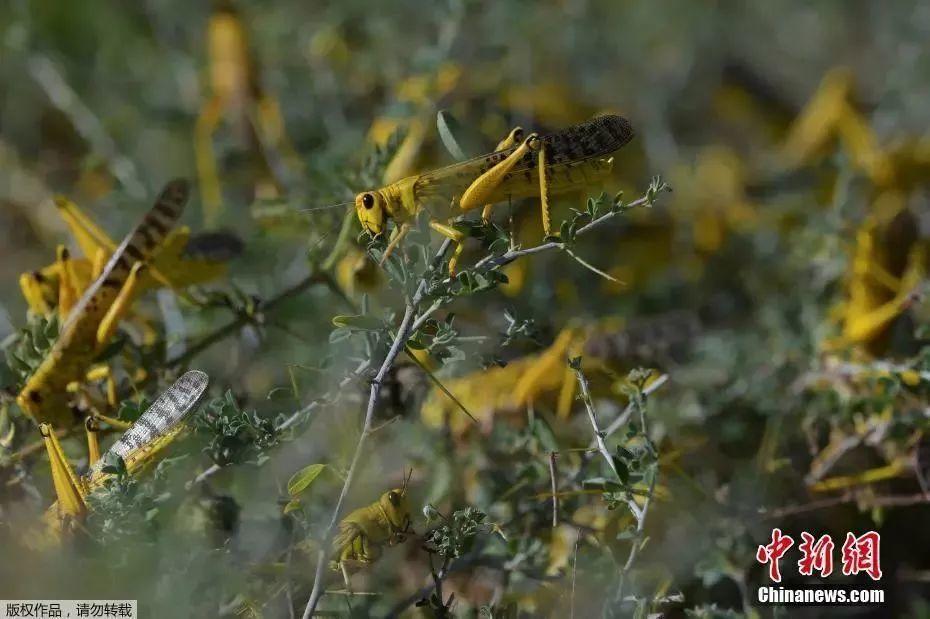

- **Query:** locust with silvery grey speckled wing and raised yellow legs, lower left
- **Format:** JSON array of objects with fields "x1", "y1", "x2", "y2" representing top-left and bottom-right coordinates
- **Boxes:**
[{"x1": 39, "y1": 370, "x2": 209, "y2": 533}]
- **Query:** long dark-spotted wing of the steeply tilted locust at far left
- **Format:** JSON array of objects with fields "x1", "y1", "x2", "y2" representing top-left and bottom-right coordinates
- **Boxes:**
[{"x1": 17, "y1": 180, "x2": 190, "y2": 426}]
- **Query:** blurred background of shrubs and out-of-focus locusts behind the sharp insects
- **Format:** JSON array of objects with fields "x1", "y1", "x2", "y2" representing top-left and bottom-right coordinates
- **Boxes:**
[{"x1": 0, "y1": 0, "x2": 930, "y2": 617}]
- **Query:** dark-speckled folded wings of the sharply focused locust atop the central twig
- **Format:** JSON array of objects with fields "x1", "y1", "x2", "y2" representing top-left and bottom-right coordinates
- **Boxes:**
[{"x1": 414, "y1": 115, "x2": 633, "y2": 209}]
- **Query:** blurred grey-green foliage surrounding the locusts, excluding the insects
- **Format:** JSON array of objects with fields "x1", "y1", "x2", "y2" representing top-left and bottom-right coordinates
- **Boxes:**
[{"x1": 0, "y1": 0, "x2": 930, "y2": 617}]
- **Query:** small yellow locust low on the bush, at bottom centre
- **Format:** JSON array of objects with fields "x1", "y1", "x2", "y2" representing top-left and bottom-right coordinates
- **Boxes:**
[{"x1": 334, "y1": 471, "x2": 413, "y2": 589}]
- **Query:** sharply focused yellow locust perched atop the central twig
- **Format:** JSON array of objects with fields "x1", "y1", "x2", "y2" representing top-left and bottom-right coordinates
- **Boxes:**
[{"x1": 355, "y1": 115, "x2": 633, "y2": 275}]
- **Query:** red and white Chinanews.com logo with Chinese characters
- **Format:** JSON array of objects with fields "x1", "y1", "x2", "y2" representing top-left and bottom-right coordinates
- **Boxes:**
[{"x1": 756, "y1": 529, "x2": 885, "y2": 606}]
